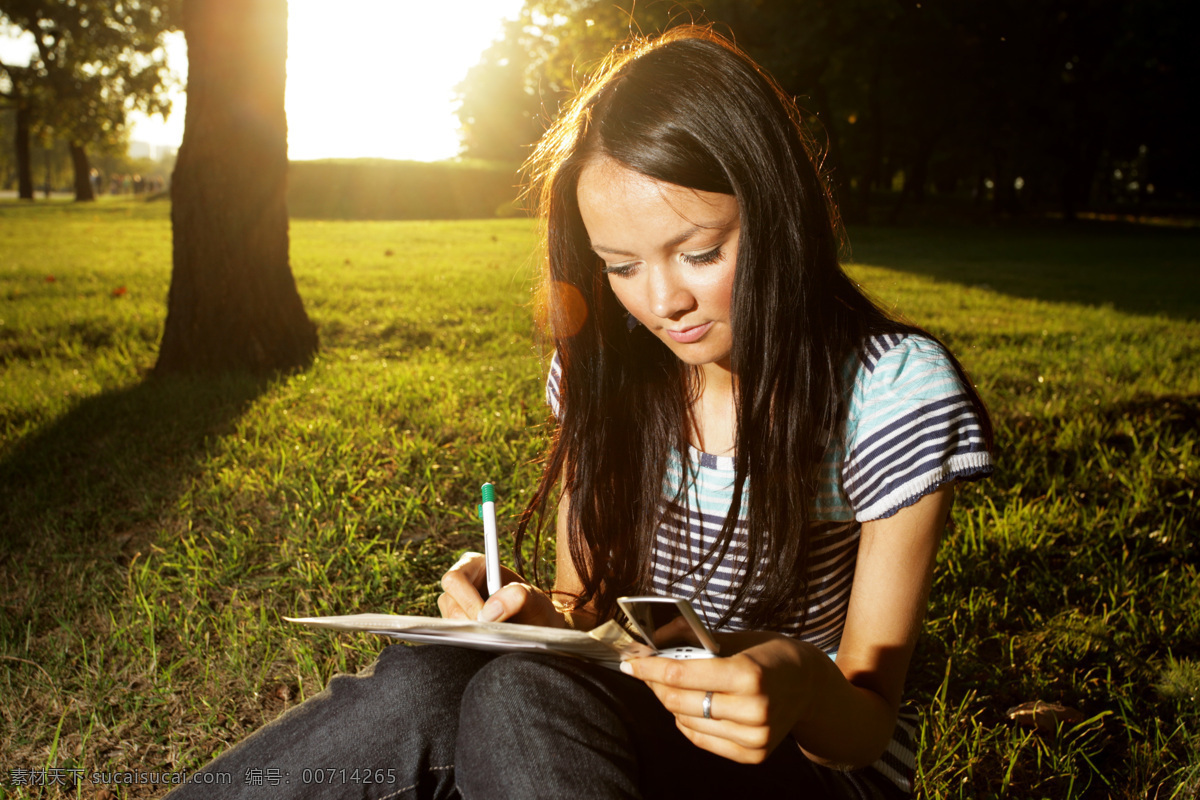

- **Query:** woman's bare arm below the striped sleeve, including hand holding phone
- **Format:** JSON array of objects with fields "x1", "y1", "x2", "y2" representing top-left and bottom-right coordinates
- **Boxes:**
[{"x1": 623, "y1": 487, "x2": 952, "y2": 766}]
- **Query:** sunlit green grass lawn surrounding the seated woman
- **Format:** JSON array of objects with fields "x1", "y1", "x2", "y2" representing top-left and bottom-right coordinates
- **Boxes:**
[{"x1": 0, "y1": 195, "x2": 1200, "y2": 800}]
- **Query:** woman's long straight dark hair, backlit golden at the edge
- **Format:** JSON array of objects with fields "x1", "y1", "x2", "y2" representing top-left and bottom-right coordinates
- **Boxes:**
[{"x1": 516, "y1": 26, "x2": 990, "y2": 627}]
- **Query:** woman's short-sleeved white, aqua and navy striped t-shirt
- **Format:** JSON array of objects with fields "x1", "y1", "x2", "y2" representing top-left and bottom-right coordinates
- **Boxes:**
[{"x1": 546, "y1": 333, "x2": 991, "y2": 792}]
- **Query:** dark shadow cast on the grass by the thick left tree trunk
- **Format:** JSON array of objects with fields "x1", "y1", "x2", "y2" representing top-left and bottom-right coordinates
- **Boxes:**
[{"x1": 0, "y1": 375, "x2": 269, "y2": 556}]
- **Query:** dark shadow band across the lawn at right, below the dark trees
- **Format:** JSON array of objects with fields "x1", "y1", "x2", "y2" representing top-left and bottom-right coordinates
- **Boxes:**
[{"x1": 850, "y1": 222, "x2": 1200, "y2": 320}]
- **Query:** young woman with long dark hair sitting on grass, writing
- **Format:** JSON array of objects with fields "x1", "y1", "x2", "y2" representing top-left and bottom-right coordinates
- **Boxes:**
[{"x1": 173, "y1": 28, "x2": 991, "y2": 799}]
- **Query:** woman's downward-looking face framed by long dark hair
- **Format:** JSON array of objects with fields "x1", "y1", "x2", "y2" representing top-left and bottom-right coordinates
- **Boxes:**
[{"x1": 577, "y1": 158, "x2": 740, "y2": 379}]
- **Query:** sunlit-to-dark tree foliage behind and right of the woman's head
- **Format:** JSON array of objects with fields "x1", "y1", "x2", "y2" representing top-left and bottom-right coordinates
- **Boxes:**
[{"x1": 458, "y1": 0, "x2": 1200, "y2": 218}]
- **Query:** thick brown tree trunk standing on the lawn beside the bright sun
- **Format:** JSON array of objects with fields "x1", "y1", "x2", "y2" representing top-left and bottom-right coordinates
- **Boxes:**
[{"x1": 155, "y1": 0, "x2": 317, "y2": 373}]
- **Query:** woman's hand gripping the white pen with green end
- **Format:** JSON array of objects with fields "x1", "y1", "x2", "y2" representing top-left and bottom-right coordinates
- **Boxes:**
[{"x1": 438, "y1": 553, "x2": 566, "y2": 627}]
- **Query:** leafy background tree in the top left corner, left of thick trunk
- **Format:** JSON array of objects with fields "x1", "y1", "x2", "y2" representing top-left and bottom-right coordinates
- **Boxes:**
[{"x1": 0, "y1": 0, "x2": 178, "y2": 200}]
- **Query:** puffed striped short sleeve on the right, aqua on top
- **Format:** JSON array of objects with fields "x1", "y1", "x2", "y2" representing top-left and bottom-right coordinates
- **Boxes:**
[{"x1": 841, "y1": 335, "x2": 991, "y2": 522}]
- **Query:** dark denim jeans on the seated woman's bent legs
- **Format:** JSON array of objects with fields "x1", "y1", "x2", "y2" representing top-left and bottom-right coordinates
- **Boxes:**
[{"x1": 169, "y1": 645, "x2": 902, "y2": 800}]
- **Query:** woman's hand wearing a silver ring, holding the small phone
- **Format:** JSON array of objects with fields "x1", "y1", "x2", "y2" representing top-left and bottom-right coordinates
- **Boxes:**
[{"x1": 622, "y1": 632, "x2": 828, "y2": 764}]
